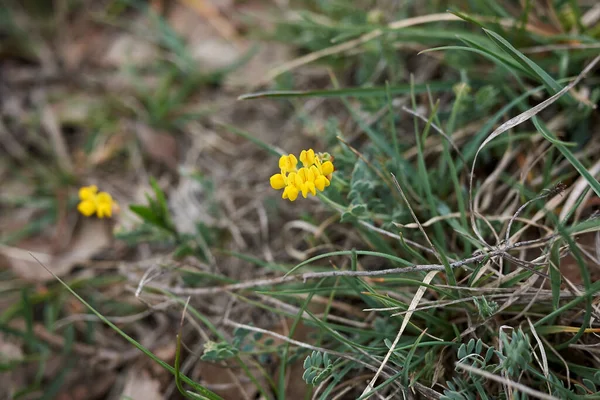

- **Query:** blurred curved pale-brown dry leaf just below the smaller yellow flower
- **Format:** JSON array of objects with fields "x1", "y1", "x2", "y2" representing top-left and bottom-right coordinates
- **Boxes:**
[{"x1": 0, "y1": 217, "x2": 112, "y2": 282}]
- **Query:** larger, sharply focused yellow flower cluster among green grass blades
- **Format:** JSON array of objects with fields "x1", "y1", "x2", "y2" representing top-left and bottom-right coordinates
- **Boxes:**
[{"x1": 271, "y1": 149, "x2": 333, "y2": 201}]
